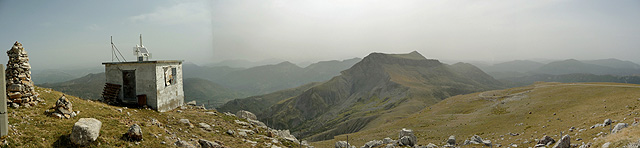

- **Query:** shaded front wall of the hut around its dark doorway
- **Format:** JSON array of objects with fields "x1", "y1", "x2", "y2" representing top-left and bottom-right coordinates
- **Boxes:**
[{"x1": 105, "y1": 63, "x2": 157, "y2": 104}]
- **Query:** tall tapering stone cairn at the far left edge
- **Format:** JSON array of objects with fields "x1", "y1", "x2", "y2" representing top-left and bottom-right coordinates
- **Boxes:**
[{"x1": 5, "y1": 41, "x2": 42, "y2": 108}]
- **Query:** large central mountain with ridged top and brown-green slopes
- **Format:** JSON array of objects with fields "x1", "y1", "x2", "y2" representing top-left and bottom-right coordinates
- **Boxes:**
[{"x1": 218, "y1": 52, "x2": 502, "y2": 141}]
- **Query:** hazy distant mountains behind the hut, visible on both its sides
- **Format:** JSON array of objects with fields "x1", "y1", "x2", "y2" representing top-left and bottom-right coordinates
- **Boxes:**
[{"x1": 36, "y1": 58, "x2": 360, "y2": 108}]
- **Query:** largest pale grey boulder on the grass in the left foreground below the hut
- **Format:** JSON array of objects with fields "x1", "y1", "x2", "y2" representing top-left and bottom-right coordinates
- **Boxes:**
[{"x1": 69, "y1": 118, "x2": 102, "y2": 146}]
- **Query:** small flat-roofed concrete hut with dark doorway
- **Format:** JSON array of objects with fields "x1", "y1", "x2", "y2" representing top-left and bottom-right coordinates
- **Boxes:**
[{"x1": 102, "y1": 60, "x2": 184, "y2": 112}]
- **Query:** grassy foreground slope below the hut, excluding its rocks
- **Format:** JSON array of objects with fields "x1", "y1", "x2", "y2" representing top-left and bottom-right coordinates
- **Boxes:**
[{"x1": 5, "y1": 88, "x2": 298, "y2": 147}]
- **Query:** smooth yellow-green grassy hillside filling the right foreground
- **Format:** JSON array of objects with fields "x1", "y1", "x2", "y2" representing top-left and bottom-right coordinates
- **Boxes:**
[{"x1": 313, "y1": 83, "x2": 640, "y2": 147}]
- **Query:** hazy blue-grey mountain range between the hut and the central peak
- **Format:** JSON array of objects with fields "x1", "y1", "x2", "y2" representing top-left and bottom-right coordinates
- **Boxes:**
[{"x1": 183, "y1": 58, "x2": 361, "y2": 97}]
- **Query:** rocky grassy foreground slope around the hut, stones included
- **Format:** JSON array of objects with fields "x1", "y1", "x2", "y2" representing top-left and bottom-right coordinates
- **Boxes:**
[{"x1": 2, "y1": 88, "x2": 304, "y2": 148}]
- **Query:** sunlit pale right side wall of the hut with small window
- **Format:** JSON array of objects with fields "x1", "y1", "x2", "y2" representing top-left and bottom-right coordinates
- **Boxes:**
[{"x1": 155, "y1": 62, "x2": 184, "y2": 112}]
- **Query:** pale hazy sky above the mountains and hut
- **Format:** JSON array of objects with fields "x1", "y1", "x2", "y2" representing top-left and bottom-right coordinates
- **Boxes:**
[{"x1": 0, "y1": 0, "x2": 640, "y2": 68}]
